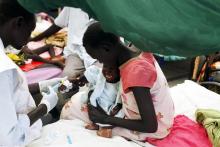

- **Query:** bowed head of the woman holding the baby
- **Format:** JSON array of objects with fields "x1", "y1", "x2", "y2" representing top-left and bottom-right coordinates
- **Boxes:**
[{"x1": 83, "y1": 23, "x2": 120, "y2": 67}]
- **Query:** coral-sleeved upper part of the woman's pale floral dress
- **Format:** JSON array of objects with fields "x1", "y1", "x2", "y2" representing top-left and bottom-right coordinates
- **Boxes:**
[{"x1": 120, "y1": 52, "x2": 174, "y2": 139}]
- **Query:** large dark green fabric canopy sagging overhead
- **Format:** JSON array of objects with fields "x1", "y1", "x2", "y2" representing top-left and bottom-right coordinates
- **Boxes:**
[{"x1": 18, "y1": 0, "x2": 220, "y2": 57}]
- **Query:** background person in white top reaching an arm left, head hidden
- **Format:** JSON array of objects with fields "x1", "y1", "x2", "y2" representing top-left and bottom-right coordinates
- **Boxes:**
[{"x1": 30, "y1": 7, "x2": 96, "y2": 79}]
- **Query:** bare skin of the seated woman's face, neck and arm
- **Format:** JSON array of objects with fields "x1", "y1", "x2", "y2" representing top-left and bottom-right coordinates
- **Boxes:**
[{"x1": 85, "y1": 41, "x2": 158, "y2": 133}]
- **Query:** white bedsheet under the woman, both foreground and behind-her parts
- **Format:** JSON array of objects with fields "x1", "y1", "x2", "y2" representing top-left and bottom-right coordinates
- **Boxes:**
[{"x1": 28, "y1": 81, "x2": 220, "y2": 147}]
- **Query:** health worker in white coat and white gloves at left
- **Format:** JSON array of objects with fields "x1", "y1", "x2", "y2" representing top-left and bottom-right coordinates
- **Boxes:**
[{"x1": 0, "y1": 0, "x2": 64, "y2": 146}]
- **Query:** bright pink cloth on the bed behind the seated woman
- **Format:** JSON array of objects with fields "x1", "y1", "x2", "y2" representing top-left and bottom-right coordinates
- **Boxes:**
[{"x1": 146, "y1": 115, "x2": 212, "y2": 147}]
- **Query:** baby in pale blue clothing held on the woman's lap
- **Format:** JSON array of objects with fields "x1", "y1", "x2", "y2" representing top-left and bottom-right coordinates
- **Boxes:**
[{"x1": 61, "y1": 65, "x2": 124, "y2": 138}]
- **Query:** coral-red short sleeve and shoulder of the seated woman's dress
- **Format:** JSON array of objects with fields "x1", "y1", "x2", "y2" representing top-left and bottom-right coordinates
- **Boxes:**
[{"x1": 120, "y1": 53, "x2": 157, "y2": 92}]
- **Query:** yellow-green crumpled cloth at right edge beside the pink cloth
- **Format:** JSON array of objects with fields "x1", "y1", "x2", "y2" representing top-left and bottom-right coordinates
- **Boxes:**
[{"x1": 196, "y1": 109, "x2": 220, "y2": 147}]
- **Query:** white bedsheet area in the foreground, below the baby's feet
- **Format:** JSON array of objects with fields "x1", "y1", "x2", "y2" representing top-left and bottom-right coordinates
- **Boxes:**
[{"x1": 28, "y1": 120, "x2": 152, "y2": 147}]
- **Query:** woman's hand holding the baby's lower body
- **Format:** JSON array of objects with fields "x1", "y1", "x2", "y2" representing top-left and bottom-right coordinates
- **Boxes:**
[{"x1": 88, "y1": 104, "x2": 108, "y2": 124}]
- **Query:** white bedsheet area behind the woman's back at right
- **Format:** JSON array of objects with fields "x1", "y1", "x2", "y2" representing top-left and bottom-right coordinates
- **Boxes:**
[{"x1": 171, "y1": 80, "x2": 220, "y2": 120}]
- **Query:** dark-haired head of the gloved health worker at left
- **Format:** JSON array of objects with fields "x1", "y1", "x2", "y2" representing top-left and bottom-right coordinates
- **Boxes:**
[{"x1": 0, "y1": 0, "x2": 35, "y2": 49}]
